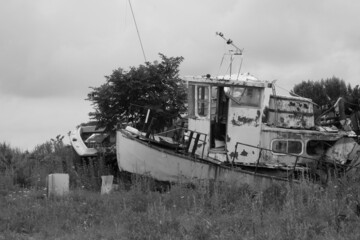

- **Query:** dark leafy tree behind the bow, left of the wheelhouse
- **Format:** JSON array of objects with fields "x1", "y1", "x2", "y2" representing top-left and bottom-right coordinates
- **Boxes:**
[{"x1": 86, "y1": 54, "x2": 186, "y2": 131}]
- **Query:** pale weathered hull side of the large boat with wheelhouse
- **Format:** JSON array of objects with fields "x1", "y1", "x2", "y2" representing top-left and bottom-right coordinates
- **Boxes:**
[{"x1": 116, "y1": 129, "x2": 286, "y2": 187}]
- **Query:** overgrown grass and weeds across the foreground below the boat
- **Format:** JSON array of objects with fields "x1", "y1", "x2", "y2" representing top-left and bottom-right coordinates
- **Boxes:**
[{"x1": 0, "y1": 140, "x2": 360, "y2": 240}]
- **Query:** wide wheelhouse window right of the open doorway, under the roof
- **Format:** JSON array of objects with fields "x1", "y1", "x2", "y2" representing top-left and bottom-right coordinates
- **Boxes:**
[{"x1": 230, "y1": 87, "x2": 261, "y2": 107}]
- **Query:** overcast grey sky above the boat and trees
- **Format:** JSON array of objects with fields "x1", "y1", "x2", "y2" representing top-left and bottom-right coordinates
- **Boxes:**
[{"x1": 0, "y1": 0, "x2": 360, "y2": 150}]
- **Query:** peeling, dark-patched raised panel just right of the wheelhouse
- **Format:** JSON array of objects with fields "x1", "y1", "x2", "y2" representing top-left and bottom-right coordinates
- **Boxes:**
[{"x1": 267, "y1": 96, "x2": 315, "y2": 129}]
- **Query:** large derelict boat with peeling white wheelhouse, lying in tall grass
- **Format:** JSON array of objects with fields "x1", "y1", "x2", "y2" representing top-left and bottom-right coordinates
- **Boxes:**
[{"x1": 116, "y1": 75, "x2": 360, "y2": 188}]
